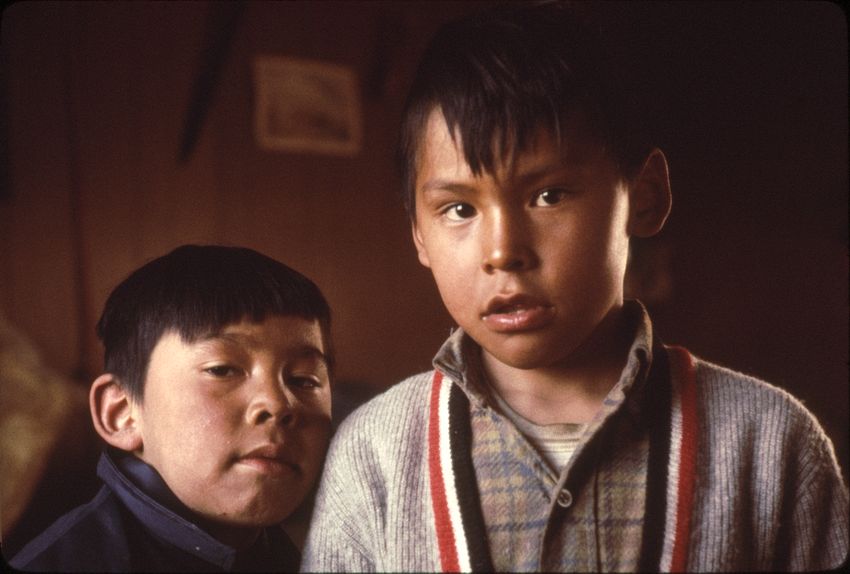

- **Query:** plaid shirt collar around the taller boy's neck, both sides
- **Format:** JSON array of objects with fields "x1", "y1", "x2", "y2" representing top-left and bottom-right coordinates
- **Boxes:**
[{"x1": 433, "y1": 300, "x2": 653, "y2": 424}]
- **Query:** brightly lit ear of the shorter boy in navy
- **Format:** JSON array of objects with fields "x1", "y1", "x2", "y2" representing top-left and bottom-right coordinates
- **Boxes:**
[{"x1": 89, "y1": 373, "x2": 142, "y2": 452}]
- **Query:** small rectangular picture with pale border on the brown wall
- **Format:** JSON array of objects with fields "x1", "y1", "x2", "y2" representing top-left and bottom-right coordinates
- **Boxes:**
[{"x1": 254, "y1": 56, "x2": 363, "y2": 156}]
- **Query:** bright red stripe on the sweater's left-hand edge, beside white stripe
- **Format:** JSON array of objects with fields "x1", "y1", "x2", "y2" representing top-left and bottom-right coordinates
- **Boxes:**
[{"x1": 428, "y1": 371, "x2": 460, "y2": 572}]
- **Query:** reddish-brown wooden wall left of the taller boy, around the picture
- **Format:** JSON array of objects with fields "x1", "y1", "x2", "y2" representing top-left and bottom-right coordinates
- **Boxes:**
[{"x1": 0, "y1": 2, "x2": 476, "y2": 392}]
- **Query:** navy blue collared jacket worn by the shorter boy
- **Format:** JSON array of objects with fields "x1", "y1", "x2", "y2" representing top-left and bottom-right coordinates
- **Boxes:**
[{"x1": 5, "y1": 453, "x2": 300, "y2": 572}]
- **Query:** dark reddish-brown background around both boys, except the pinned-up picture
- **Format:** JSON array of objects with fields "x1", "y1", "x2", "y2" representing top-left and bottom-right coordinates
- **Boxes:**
[{"x1": 0, "y1": 2, "x2": 849, "y2": 554}]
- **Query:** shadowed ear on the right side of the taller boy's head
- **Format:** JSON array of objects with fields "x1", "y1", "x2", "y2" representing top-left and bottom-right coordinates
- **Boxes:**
[{"x1": 628, "y1": 148, "x2": 672, "y2": 237}]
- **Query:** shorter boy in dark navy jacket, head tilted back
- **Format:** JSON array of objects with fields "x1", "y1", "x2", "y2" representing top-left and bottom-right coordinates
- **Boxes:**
[{"x1": 11, "y1": 246, "x2": 333, "y2": 572}]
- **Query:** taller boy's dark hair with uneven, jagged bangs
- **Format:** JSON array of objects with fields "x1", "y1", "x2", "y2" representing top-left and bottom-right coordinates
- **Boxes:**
[{"x1": 398, "y1": 2, "x2": 651, "y2": 218}]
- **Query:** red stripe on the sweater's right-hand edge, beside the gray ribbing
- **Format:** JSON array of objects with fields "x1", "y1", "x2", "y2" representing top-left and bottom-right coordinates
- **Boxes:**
[{"x1": 670, "y1": 347, "x2": 699, "y2": 572}]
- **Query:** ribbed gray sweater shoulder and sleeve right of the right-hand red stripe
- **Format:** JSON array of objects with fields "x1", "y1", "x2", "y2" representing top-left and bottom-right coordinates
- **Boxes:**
[{"x1": 689, "y1": 361, "x2": 850, "y2": 572}]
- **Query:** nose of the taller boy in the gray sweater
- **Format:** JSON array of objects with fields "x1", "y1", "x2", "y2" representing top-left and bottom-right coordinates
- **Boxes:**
[{"x1": 482, "y1": 213, "x2": 537, "y2": 273}]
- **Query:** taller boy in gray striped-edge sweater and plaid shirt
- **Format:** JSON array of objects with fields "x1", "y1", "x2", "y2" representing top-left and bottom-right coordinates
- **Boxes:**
[{"x1": 302, "y1": 3, "x2": 848, "y2": 571}]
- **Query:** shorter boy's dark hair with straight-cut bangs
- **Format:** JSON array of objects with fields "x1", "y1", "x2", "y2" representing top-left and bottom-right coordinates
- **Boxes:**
[{"x1": 97, "y1": 245, "x2": 333, "y2": 400}]
